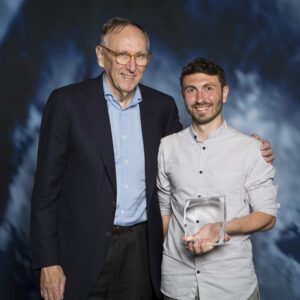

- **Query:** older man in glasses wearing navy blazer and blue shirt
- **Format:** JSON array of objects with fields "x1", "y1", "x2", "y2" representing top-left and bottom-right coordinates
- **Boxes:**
[{"x1": 31, "y1": 18, "x2": 272, "y2": 300}]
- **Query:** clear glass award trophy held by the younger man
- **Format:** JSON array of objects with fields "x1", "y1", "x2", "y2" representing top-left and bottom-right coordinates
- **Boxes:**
[{"x1": 183, "y1": 196, "x2": 226, "y2": 246}]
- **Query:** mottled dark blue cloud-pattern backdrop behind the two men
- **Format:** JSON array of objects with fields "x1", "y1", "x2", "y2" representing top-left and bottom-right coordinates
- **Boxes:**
[{"x1": 0, "y1": 0, "x2": 300, "y2": 300}]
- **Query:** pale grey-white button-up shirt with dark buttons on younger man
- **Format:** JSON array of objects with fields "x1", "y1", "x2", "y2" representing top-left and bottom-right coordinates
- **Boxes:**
[{"x1": 157, "y1": 121, "x2": 278, "y2": 300}]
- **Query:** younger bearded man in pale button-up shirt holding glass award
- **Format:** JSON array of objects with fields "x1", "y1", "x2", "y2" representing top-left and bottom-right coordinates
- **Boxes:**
[{"x1": 157, "y1": 58, "x2": 278, "y2": 300}]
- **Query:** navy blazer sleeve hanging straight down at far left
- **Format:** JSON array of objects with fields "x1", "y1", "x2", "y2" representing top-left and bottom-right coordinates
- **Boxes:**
[{"x1": 30, "y1": 91, "x2": 69, "y2": 269}]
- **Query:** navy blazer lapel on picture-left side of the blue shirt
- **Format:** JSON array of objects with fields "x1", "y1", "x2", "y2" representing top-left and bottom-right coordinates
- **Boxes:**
[{"x1": 86, "y1": 75, "x2": 117, "y2": 194}]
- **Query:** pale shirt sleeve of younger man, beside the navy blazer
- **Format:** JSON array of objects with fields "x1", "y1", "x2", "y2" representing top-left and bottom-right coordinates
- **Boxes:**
[{"x1": 157, "y1": 142, "x2": 172, "y2": 216}]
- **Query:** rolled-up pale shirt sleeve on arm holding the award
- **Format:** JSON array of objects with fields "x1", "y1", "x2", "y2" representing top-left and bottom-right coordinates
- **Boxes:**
[{"x1": 245, "y1": 143, "x2": 279, "y2": 217}]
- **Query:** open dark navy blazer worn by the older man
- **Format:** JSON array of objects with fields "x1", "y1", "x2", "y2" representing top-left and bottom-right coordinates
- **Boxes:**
[{"x1": 31, "y1": 75, "x2": 182, "y2": 300}]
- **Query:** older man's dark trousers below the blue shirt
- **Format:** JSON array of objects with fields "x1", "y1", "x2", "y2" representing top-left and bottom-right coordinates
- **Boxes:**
[{"x1": 88, "y1": 223, "x2": 153, "y2": 300}]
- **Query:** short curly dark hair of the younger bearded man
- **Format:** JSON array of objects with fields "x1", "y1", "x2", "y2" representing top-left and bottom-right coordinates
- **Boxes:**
[{"x1": 180, "y1": 57, "x2": 226, "y2": 89}]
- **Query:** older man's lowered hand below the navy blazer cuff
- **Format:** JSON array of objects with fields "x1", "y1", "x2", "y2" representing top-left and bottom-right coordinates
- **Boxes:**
[{"x1": 40, "y1": 265, "x2": 66, "y2": 300}]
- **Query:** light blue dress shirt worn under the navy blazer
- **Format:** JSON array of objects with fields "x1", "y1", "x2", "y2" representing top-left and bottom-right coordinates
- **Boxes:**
[{"x1": 103, "y1": 76, "x2": 147, "y2": 226}]
